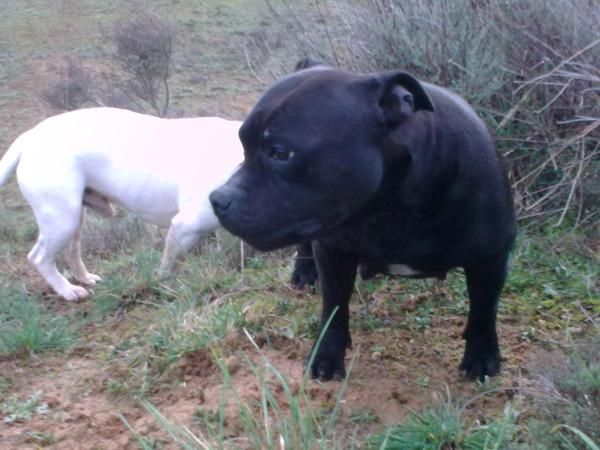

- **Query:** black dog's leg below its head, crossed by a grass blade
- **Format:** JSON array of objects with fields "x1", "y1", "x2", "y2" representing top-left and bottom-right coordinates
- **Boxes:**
[{"x1": 310, "y1": 242, "x2": 358, "y2": 380}]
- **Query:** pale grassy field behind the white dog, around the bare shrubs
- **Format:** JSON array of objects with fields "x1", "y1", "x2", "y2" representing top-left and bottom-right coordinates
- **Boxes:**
[{"x1": 0, "y1": 0, "x2": 276, "y2": 153}]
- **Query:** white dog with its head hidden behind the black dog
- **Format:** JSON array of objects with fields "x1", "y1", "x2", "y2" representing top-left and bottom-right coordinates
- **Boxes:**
[{"x1": 0, "y1": 108, "x2": 243, "y2": 300}]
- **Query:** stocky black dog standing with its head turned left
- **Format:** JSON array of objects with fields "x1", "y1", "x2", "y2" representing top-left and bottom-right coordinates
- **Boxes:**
[{"x1": 210, "y1": 60, "x2": 516, "y2": 379}]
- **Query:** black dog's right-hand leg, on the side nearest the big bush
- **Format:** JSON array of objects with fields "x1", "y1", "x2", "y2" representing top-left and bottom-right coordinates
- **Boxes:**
[{"x1": 459, "y1": 256, "x2": 507, "y2": 381}]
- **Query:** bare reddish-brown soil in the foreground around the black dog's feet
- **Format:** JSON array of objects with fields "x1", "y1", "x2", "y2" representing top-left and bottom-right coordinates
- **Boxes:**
[{"x1": 0, "y1": 296, "x2": 539, "y2": 450}]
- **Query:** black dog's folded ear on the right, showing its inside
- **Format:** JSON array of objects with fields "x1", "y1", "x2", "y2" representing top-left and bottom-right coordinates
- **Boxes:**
[{"x1": 377, "y1": 71, "x2": 434, "y2": 127}]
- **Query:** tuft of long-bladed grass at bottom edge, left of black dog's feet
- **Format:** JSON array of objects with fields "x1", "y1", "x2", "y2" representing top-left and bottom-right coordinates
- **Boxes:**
[{"x1": 121, "y1": 326, "x2": 357, "y2": 450}]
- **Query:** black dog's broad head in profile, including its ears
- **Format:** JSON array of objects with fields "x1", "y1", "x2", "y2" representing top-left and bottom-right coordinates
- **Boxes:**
[{"x1": 210, "y1": 59, "x2": 433, "y2": 250}]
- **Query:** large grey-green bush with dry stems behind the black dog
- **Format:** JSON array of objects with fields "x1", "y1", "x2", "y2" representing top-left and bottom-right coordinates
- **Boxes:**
[{"x1": 254, "y1": 0, "x2": 600, "y2": 230}]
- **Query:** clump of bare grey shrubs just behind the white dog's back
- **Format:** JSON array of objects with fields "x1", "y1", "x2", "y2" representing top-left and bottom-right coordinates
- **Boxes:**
[{"x1": 39, "y1": 13, "x2": 175, "y2": 117}]
